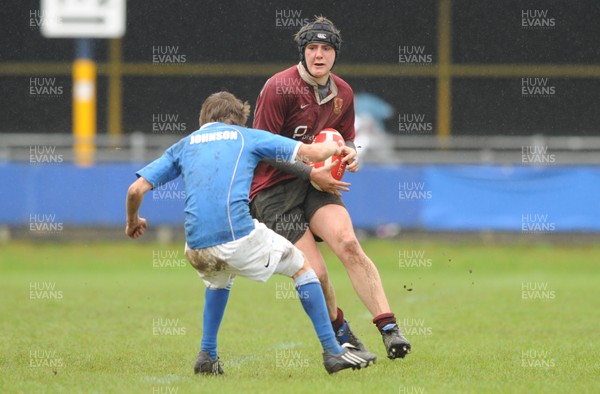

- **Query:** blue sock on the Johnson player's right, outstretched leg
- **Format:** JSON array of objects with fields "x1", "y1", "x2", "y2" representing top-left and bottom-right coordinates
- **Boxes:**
[{"x1": 294, "y1": 270, "x2": 343, "y2": 355}]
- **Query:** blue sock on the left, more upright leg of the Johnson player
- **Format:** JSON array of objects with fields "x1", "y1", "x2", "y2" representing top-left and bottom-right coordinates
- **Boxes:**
[{"x1": 200, "y1": 284, "x2": 231, "y2": 360}]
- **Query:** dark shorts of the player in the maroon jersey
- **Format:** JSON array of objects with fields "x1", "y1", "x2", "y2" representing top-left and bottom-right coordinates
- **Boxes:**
[{"x1": 250, "y1": 178, "x2": 345, "y2": 244}]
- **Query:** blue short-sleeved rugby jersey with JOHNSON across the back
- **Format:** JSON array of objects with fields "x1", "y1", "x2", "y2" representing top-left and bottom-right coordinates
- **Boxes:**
[{"x1": 136, "y1": 123, "x2": 302, "y2": 249}]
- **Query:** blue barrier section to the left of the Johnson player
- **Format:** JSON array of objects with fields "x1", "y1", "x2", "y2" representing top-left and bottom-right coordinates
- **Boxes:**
[{"x1": 0, "y1": 164, "x2": 183, "y2": 226}]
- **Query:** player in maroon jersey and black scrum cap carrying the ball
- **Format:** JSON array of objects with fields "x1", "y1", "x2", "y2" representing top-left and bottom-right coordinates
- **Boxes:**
[{"x1": 250, "y1": 16, "x2": 411, "y2": 359}]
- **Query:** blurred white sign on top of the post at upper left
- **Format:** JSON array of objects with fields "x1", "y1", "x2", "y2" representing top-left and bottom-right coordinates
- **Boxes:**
[{"x1": 41, "y1": 0, "x2": 126, "y2": 38}]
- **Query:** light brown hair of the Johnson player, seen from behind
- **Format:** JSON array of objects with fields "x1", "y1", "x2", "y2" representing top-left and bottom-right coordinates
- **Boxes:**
[{"x1": 200, "y1": 92, "x2": 250, "y2": 127}]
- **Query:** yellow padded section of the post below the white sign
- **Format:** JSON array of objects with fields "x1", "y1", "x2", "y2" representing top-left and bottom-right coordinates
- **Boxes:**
[{"x1": 73, "y1": 58, "x2": 97, "y2": 167}]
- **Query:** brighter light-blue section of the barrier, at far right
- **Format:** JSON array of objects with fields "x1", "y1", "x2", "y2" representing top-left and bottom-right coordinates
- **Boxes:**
[{"x1": 422, "y1": 165, "x2": 600, "y2": 232}]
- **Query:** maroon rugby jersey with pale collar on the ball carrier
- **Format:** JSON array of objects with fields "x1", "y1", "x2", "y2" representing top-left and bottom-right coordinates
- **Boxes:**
[{"x1": 250, "y1": 64, "x2": 354, "y2": 200}]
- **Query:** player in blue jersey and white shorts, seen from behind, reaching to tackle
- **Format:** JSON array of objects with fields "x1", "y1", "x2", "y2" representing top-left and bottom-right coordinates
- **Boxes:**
[{"x1": 125, "y1": 92, "x2": 376, "y2": 375}]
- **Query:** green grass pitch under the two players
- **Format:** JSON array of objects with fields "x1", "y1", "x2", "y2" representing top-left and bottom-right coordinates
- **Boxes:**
[{"x1": 0, "y1": 240, "x2": 600, "y2": 394}]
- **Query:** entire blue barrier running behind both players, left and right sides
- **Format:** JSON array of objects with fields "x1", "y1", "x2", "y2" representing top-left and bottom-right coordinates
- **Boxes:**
[{"x1": 0, "y1": 163, "x2": 600, "y2": 232}]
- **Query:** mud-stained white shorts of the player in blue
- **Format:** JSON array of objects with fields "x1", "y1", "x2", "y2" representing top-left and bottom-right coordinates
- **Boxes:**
[{"x1": 185, "y1": 220, "x2": 304, "y2": 289}]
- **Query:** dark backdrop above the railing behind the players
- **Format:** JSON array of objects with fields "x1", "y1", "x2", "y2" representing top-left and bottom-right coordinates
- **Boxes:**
[{"x1": 0, "y1": 0, "x2": 600, "y2": 136}]
